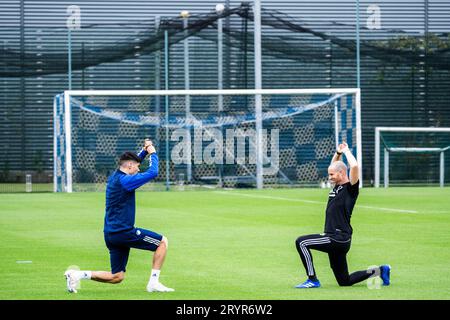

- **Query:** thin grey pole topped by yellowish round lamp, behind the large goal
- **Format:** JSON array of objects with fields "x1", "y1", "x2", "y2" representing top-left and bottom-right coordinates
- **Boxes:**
[{"x1": 180, "y1": 11, "x2": 192, "y2": 181}]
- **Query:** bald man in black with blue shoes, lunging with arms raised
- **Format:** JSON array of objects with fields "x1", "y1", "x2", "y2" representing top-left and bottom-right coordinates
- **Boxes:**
[{"x1": 295, "y1": 143, "x2": 391, "y2": 289}]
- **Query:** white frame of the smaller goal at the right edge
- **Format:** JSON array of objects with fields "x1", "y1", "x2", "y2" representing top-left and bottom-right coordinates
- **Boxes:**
[{"x1": 374, "y1": 127, "x2": 450, "y2": 188}]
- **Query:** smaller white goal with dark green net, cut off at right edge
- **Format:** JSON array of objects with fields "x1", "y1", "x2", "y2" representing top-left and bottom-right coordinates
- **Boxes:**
[{"x1": 375, "y1": 127, "x2": 450, "y2": 187}]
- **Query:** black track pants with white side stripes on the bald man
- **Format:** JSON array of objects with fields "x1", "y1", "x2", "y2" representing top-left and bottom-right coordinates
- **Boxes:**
[{"x1": 295, "y1": 234, "x2": 374, "y2": 286}]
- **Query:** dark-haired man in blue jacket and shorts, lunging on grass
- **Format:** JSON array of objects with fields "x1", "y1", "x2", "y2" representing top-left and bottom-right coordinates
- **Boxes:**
[{"x1": 64, "y1": 140, "x2": 174, "y2": 293}]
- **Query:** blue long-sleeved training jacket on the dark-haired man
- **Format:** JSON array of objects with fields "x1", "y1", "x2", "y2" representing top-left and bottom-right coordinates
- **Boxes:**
[{"x1": 103, "y1": 150, "x2": 158, "y2": 233}]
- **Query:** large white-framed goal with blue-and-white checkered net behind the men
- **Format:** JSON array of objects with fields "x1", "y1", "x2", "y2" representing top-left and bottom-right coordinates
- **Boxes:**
[{"x1": 54, "y1": 89, "x2": 361, "y2": 192}]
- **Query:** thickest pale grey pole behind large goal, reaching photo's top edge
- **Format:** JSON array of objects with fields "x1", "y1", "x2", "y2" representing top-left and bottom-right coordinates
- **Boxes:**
[{"x1": 253, "y1": 0, "x2": 263, "y2": 189}]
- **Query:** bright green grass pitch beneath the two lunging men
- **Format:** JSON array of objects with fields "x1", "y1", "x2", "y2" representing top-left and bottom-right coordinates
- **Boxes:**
[{"x1": 0, "y1": 188, "x2": 450, "y2": 300}]
